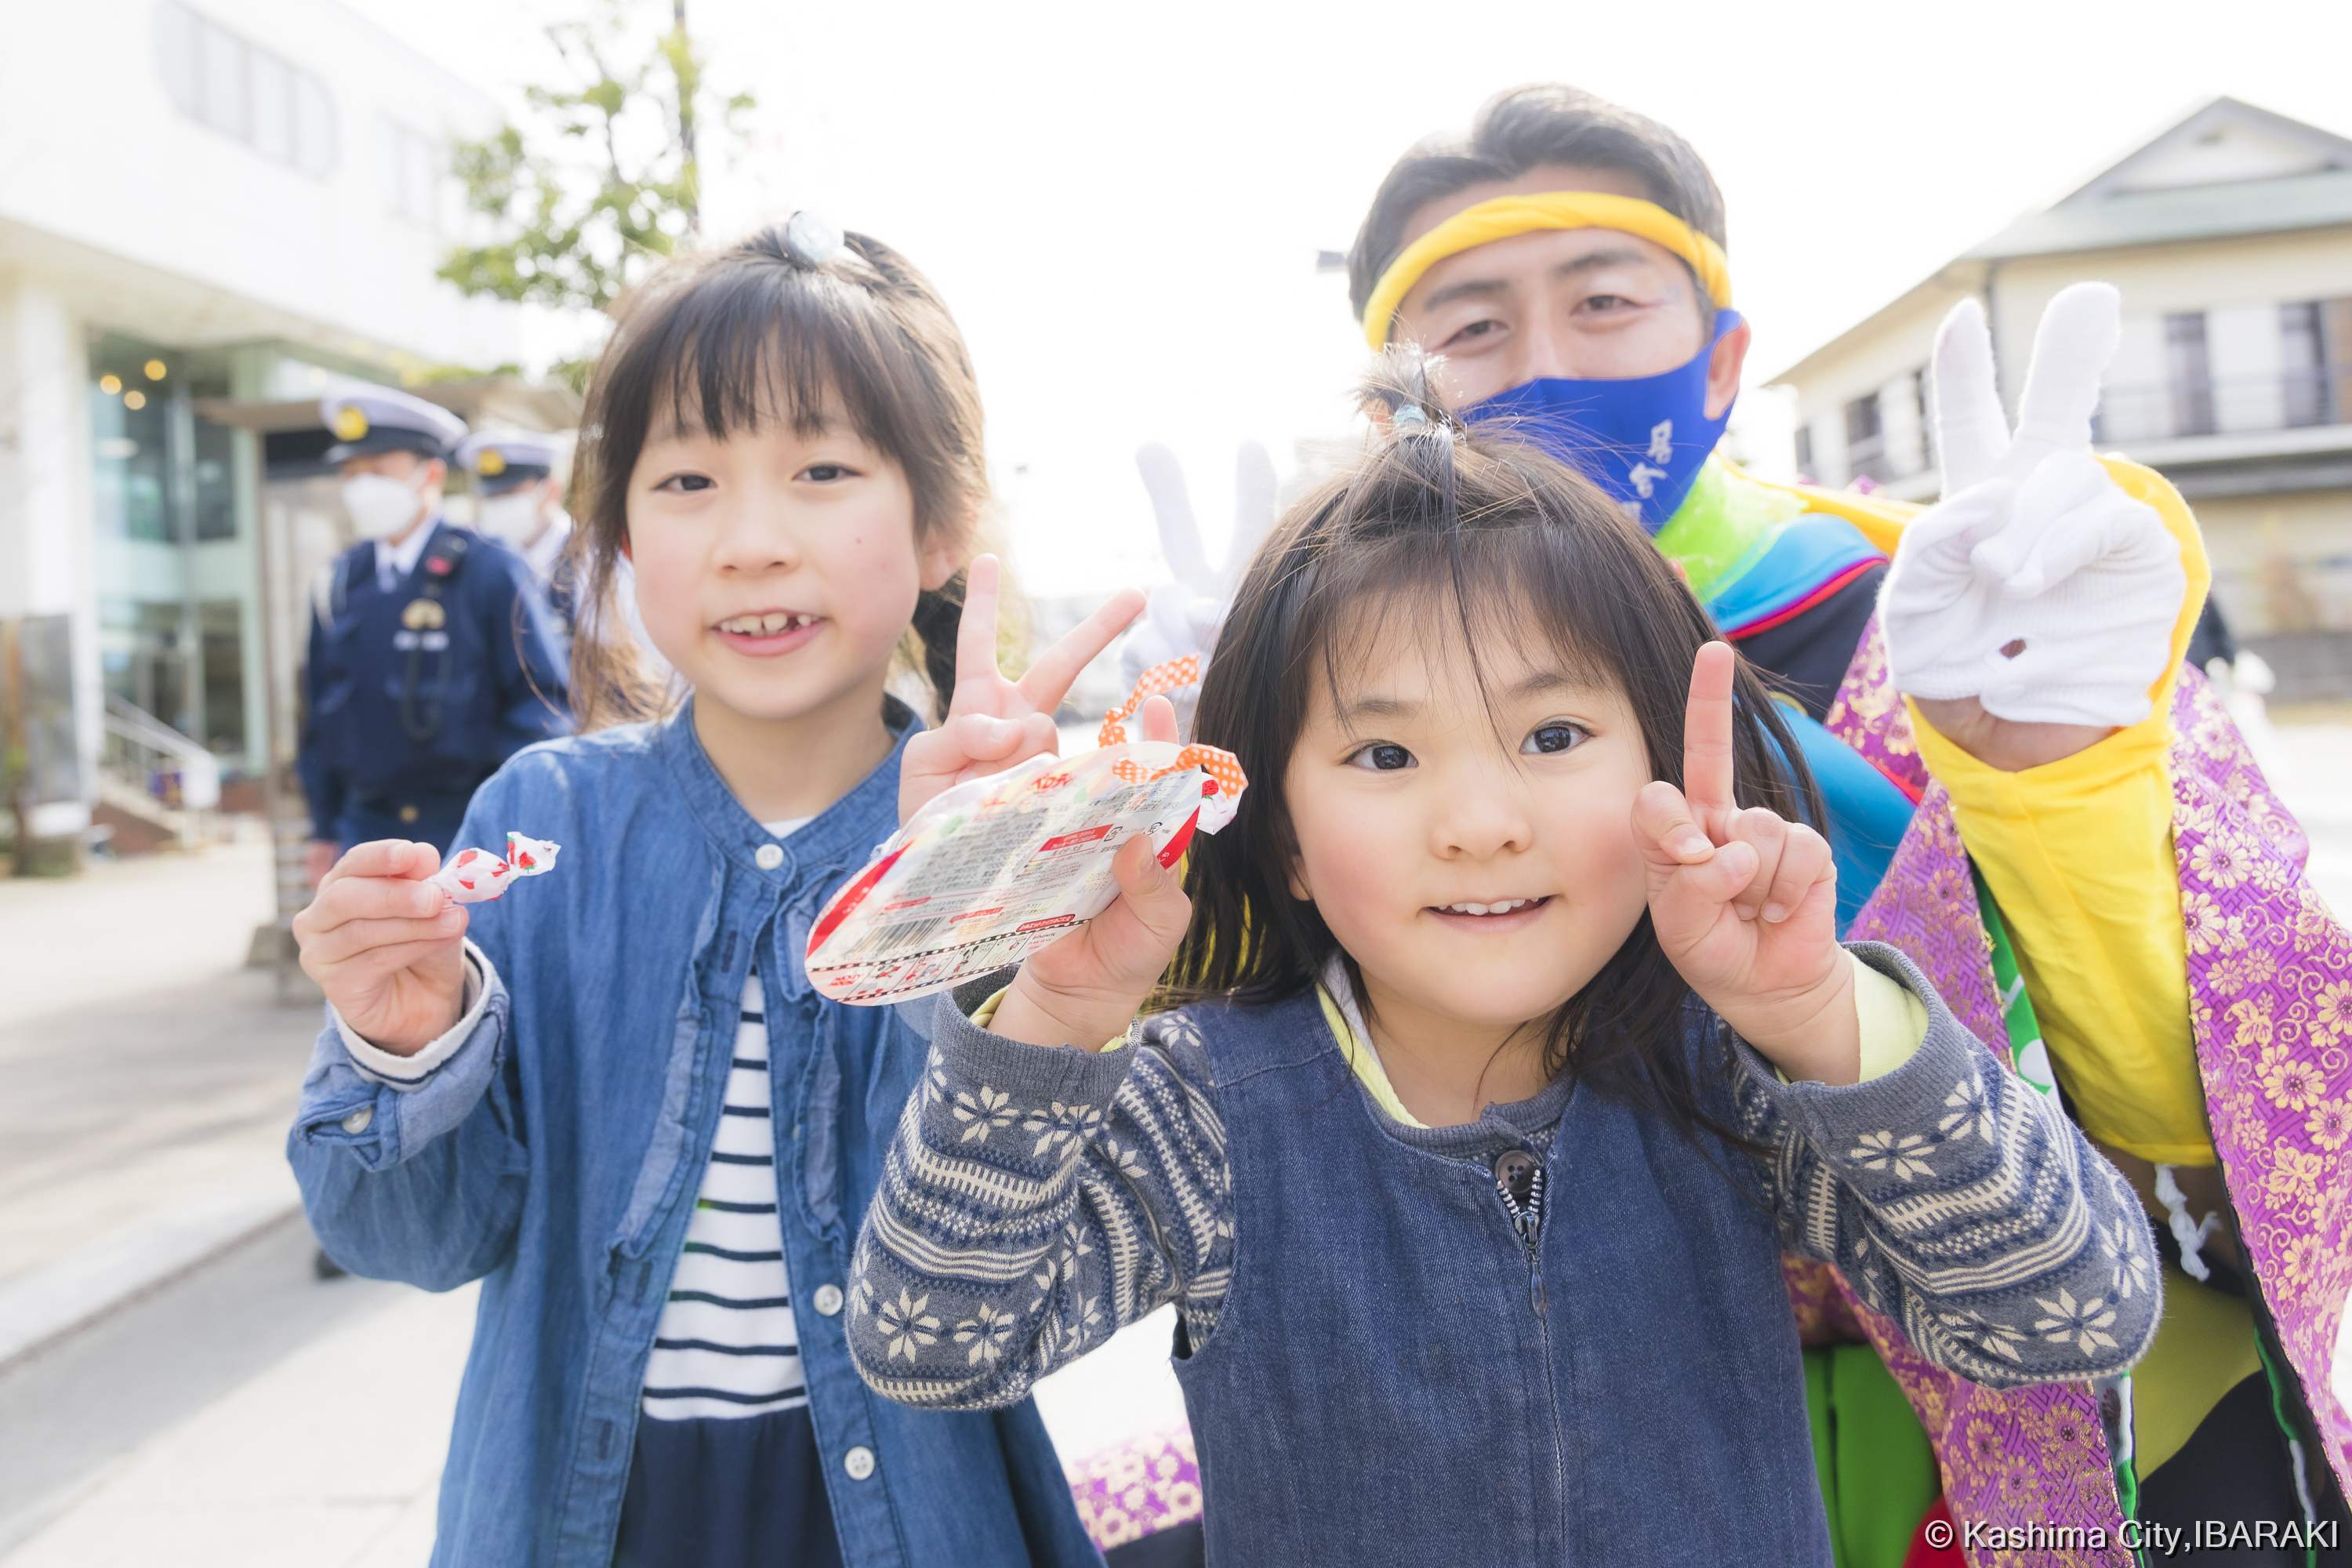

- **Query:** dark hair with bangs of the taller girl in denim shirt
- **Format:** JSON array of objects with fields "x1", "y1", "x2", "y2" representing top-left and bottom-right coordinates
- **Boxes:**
[{"x1": 572, "y1": 212, "x2": 1018, "y2": 731}]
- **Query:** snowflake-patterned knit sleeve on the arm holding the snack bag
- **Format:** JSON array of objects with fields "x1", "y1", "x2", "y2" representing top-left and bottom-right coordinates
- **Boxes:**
[{"x1": 849, "y1": 992, "x2": 1232, "y2": 1410}]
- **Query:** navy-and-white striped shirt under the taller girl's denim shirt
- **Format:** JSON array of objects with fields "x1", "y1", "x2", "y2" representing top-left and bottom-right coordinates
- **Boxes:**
[{"x1": 644, "y1": 822, "x2": 809, "y2": 1420}]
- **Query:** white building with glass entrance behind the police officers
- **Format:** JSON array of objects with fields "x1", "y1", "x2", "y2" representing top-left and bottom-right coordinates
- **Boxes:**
[{"x1": 0, "y1": 0, "x2": 517, "y2": 834}]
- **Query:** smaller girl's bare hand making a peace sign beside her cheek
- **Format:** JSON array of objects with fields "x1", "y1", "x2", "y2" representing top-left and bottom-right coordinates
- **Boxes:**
[{"x1": 1632, "y1": 642, "x2": 1860, "y2": 1083}]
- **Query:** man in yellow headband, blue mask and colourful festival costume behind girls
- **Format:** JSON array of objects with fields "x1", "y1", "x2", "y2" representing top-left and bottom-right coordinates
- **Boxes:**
[{"x1": 1350, "y1": 87, "x2": 2352, "y2": 1568}]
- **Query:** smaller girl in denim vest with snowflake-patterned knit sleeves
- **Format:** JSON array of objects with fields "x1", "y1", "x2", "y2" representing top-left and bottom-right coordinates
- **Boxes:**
[{"x1": 849, "y1": 365, "x2": 2157, "y2": 1566}]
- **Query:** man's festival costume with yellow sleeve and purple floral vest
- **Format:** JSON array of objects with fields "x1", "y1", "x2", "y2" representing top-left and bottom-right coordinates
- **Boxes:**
[{"x1": 1731, "y1": 461, "x2": 2352, "y2": 1563}]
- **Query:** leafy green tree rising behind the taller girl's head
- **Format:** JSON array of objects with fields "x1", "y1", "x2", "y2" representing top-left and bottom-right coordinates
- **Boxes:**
[{"x1": 440, "y1": 0, "x2": 757, "y2": 328}]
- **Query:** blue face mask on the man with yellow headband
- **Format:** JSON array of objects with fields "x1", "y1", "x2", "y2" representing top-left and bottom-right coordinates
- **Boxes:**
[{"x1": 1461, "y1": 310, "x2": 1740, "y2": 534}]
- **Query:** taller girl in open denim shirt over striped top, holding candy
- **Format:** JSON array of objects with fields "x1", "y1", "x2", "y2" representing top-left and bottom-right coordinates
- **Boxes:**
[{"x1": 292, "y1": 214, "x2": 1141, "y2": 1568}]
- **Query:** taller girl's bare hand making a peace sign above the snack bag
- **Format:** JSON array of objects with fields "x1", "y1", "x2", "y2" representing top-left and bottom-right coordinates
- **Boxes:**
[{"x1": 898, "y1": 555, "x2": 1143, "y2": 822}]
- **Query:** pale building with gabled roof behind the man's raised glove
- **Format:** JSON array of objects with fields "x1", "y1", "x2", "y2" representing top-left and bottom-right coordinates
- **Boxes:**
[{"x1": 1776, "y1": 99, "x2": 2352, "y2": 699}]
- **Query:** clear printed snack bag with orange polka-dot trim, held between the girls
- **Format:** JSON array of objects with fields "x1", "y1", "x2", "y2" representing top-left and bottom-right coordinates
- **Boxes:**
[{"x1": 807, "y1": 719, "x2": 1249, "y2": 1006}]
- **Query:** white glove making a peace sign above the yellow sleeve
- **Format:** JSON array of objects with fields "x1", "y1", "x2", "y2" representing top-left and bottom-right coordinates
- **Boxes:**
[{"x1": 1879, "y1": 282, "x2": 2187, "y2": 727}]
